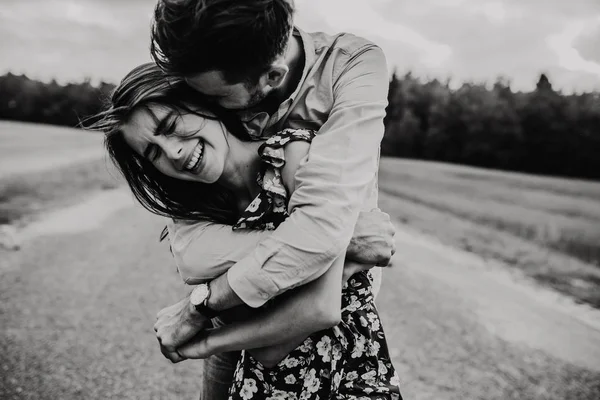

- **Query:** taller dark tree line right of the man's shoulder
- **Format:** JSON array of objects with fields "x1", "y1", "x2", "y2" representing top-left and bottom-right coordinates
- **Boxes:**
[{"x1": 382, "y1": 74, "x2": 600, "y2": 179}]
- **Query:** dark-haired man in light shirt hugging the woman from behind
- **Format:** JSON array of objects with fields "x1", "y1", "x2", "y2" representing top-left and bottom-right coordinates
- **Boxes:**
[{"x1": 152, "y1": 0, "x2": 394, "y2": 399}]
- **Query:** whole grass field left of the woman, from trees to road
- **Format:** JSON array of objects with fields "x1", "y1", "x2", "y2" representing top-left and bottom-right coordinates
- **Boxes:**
[{"x1": 0, "y1": 121, "x2": 122, "y2": 224}]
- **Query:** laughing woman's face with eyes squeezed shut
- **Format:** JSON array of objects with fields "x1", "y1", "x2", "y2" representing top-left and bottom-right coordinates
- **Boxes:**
[{"x1": 122, "y1": 105, "x2": 229, "y2": 183}]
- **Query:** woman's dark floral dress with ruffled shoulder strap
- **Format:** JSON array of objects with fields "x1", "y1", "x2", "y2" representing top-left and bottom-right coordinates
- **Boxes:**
[{"x1": 229, "y1": 129, "x2": 402, "y2": 400}]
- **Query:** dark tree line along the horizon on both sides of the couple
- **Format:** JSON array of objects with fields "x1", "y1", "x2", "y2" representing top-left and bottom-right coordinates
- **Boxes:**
[{"x1": 0, "y1": 73, "x2": 600, "y2": 179}]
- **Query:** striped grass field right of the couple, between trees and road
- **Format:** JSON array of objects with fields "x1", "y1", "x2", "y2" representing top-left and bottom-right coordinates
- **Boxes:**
[{"x1": 380, "y1": 158, "x2": 600, "y2": 307}]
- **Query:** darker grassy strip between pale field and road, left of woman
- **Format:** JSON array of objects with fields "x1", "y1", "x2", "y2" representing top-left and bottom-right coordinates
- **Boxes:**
[{"x1": 0, "y1": 160, "x2": 123, "y2": 228}]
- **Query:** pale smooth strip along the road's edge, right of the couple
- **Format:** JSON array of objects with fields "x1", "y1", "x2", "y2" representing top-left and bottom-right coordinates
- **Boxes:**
[{"x1": 384, "y1": 209, "x2": 600, "y2": 372}]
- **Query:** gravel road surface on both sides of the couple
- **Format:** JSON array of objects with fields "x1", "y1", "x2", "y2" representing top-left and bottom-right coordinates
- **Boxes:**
[{"x1": 0, "y1": 191, "x2": 600, "y2": 400}]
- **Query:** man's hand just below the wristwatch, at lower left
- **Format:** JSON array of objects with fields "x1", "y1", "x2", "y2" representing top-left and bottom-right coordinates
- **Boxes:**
[{"x1": 154, "y1": 297, "x2": 210, "y2": 363}]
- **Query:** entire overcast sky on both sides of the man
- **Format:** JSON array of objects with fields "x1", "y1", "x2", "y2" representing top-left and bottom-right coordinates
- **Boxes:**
[{"x1": 0, "y1": 0, "x2": 600, "y2": 92}]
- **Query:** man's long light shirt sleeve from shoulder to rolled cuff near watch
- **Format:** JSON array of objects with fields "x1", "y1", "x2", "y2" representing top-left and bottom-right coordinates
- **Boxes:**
[{"x1": 227, "y1": 44, "x2": 389, "y2": 307}]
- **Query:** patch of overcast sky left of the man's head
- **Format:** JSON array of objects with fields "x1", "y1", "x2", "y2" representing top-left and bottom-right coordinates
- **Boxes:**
[{"x1": 0, "y1": 0, "x2": 153, "y2": 82}]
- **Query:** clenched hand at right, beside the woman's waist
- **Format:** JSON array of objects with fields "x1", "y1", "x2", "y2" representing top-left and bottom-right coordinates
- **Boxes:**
[{"x1": 346, "y1": 208, "x2": 396, "y2": 267}]
